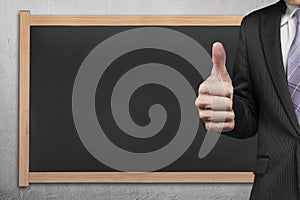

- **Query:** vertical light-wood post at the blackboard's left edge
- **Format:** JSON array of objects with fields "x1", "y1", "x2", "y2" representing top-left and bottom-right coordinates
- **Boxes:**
[{"x1": 19, "y1": 11, "x2": 30, "y2": 187}]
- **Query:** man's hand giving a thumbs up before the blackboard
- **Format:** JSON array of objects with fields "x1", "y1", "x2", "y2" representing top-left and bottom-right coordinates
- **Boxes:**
[{"x1": 195, "y1": 42, "x2": 235, "y2": 132}]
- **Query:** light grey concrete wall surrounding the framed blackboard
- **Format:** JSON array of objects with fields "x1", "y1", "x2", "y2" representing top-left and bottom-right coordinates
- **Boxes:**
[{"x1": 0, "y1": 0, "x2": 276, "y2": 200}]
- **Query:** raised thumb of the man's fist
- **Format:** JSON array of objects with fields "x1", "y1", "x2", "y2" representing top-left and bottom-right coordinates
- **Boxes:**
[{"x1": 211, "y1": 42, "x2": 231, "y2": 82}]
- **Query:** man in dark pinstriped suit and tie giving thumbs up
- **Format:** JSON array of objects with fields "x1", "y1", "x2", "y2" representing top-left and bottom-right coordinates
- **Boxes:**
[{"x1": 195, "y1": 0, "x2": 300, "y2": 200}]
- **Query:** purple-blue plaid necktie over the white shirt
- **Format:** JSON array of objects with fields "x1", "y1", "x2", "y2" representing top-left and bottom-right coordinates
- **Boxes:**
[{"x1": 287, "y1": 9, "x2": 300, "y2": 123}]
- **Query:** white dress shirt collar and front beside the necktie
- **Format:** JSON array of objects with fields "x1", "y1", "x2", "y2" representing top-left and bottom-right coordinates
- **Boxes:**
[{"x1": 280, "y1": 4, "x2": 299, "y2": 71}]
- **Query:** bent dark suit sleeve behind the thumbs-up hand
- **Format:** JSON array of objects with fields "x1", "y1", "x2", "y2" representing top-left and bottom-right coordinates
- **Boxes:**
[{"x1": 222, "y1": 17, "x2": 258, "y2": 139}]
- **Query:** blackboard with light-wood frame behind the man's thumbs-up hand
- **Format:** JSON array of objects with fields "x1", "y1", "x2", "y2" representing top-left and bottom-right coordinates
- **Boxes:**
[{"x1": 20, "y1": 12, "x2": 256, "y2": 186}]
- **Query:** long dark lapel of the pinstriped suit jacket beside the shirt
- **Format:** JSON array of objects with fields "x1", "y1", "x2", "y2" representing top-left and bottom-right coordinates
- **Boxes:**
[{"x1": 260, "y1": 1, "x2": 300, "y2": 134}]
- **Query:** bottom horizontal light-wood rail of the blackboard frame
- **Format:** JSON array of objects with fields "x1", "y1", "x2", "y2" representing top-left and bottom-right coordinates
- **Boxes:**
[{"x1": 29, "y1": 172, "x2": 254, "y2": 183}]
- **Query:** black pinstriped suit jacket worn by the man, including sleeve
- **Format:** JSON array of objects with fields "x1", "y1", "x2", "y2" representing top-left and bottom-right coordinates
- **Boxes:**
[{"x1": 223, "y1": 1, "x2": 300, "y2": 200}]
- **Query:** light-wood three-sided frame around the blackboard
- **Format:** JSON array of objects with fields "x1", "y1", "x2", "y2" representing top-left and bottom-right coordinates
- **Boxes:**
[{"x1": 19, "y1": 11, "x2": 254, "y2": 187}]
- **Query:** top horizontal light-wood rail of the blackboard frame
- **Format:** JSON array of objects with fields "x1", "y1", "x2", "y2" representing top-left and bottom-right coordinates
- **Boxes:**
[{"x1": 30, "y1": 15, "x2": 243, "y2": 26}]
